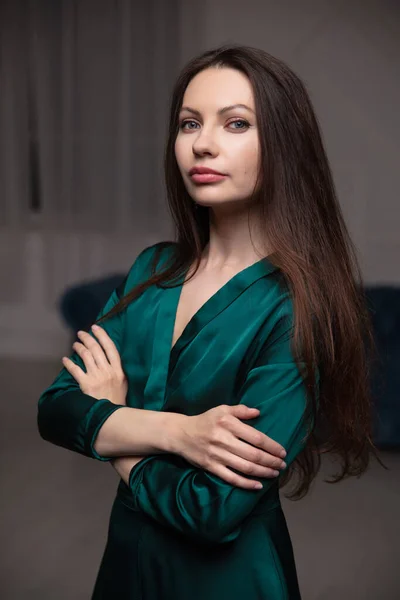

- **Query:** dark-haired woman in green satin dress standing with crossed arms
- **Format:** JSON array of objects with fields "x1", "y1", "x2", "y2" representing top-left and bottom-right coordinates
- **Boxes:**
[{"x1": 39, "y1": 46, "x2": 374, "y2": 600}]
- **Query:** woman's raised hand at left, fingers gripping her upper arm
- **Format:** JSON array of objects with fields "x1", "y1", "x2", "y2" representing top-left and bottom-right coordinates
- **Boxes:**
[{"x1": 62, "y1": 325, "x2": 128, "y2": 405}]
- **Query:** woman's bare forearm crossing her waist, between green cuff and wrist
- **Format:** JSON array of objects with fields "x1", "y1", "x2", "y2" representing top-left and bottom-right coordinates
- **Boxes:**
[{"x1": 94, "y1": 407, "x2": 187, "y2": 457}]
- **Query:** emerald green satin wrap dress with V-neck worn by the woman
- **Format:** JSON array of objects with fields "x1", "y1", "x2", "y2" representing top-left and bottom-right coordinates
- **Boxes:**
[{"x1": 38, "y1": 242, "x2": 312, "y2": 600}]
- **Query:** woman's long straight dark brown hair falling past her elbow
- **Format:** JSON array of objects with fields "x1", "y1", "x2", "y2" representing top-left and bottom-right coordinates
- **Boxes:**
[{"x1": 96, "y1": 45, "x2": 380, "y2": 499}]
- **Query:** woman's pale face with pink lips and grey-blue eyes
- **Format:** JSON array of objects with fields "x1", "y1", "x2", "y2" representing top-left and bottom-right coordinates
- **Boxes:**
[{"x1": 175, "y1": 67, "x2": 259, "y2": 207}]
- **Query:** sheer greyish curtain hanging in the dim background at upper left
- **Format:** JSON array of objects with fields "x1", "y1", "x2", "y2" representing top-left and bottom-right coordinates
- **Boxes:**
[{"x1": 0, "y1": 0, "x2": 179, "y2": 234}]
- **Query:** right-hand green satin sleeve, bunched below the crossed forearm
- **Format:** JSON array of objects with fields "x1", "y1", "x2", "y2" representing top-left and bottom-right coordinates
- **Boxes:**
[{"x1": 129, "y1": 316, "x2": 318, "y2": 543}]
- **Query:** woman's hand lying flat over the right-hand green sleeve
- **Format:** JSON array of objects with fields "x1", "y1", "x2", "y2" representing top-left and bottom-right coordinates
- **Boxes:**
[{"x1": 176, "y1": 404, "x2": 286, "y2": 489}]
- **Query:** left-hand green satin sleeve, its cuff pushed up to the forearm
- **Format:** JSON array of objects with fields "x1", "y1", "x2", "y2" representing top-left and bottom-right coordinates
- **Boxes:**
[{"x1": 37, "y1": 247, "x2": 155, "y2": 461}]
